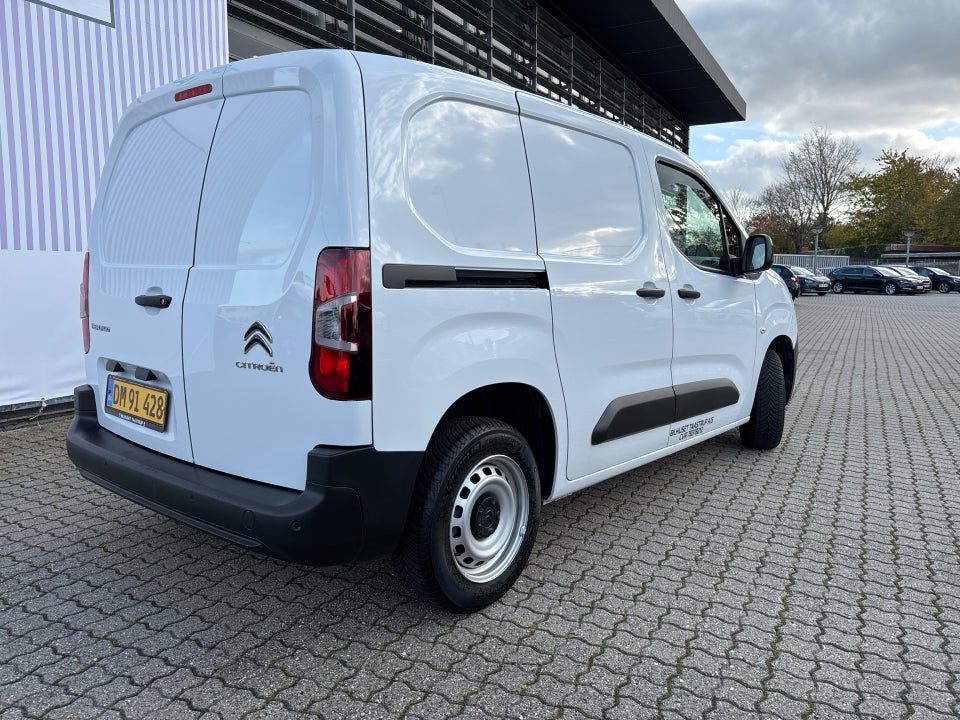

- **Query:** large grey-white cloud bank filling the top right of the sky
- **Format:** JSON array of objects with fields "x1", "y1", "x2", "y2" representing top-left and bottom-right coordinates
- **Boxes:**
[{"x1": 678, "y1": 0, "x2": 960, "y2": 133}]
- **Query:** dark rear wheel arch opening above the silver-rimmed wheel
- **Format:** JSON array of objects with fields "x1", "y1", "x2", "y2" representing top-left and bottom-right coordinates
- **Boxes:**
[{"x1": 437, "y1": 383, "x2": 557, "y2": 500}]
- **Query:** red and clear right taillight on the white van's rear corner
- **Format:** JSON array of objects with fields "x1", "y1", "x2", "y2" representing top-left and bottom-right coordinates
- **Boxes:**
[{"x1": 310, "y1": 248, "x2": 372, "y2": 400}]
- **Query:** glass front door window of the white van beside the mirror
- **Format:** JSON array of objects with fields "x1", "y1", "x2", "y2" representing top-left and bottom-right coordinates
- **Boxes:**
[{"x1": 657, "y1": 163, "x2": 740, "y2": 271}]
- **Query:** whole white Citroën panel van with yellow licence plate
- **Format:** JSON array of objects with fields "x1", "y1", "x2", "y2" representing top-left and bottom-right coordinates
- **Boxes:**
[{"x1": 67, "y1": 50, "x2": 797, "y2": 611}]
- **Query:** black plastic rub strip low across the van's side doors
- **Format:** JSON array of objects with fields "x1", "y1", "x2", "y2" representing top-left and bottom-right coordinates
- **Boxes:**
[{"x1": 590, "y1": 378, "x2": 740, "y2": 445}]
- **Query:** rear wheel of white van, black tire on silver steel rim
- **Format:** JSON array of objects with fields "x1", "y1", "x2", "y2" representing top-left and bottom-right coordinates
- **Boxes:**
[{"x1": 397, "y1": 417, "x2": 541, "y2": 612}]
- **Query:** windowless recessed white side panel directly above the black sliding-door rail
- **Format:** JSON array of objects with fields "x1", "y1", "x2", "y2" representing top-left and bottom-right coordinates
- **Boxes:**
[{"x1": 404, "y1": 99, "x2": 537, "y2": 253}]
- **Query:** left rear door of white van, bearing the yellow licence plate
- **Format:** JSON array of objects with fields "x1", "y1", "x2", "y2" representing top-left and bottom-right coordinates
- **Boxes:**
[{"x1": 86, "y1": 76, "x2": 223, "y2": 460}]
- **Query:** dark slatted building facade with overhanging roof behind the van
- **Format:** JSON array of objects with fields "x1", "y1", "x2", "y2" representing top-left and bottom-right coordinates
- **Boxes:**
[{"x1": 227, "y1": 0, "x2": 746, "y2": 151}]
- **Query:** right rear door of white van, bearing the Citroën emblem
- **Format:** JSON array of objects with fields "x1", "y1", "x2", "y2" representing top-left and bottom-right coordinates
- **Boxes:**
[{"x1": 183, "y1": 51, "x2": 373, "y2": 489}]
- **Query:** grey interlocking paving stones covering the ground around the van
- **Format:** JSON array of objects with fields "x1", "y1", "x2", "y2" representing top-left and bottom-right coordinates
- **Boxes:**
[{"x1": 0, "y1": 294, "x2": 960, "y2": 720}]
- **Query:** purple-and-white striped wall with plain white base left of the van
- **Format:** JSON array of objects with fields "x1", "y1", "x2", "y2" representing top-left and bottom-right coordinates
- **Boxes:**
[{"x1": 0, "y1": 0, "x2": 227, "y2": 411}]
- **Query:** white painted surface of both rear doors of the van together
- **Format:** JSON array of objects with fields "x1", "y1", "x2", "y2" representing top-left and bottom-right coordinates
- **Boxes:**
[{"x1": 88, "y1": 52, "x2": 372, "y2": 489}]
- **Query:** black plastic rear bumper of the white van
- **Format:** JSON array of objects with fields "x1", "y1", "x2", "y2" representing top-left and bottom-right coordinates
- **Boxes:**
[{"x1": 67, "y1": 385, "x2": 423, "y2": 565}]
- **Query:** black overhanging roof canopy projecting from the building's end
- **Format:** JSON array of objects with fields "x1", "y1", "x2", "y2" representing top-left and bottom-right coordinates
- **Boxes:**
[{"x1": 544, "y1": 0, "x2": 747, "y2": 125}]
